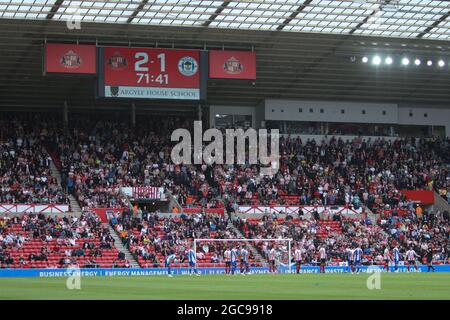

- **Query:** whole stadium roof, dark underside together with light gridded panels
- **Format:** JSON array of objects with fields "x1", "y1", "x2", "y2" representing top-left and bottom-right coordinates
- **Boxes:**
[{"x1": 0, "y1": 0, "x2": 450, "y2": 109}]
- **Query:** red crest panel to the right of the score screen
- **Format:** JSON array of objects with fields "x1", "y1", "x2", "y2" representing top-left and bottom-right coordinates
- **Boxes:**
[{"x1": 209, "y1": 50, "x2": 256, "y2": 80}]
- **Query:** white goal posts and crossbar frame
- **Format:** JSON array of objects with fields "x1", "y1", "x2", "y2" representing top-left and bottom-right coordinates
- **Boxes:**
[{"x1": 193, "y1": 238, "x2": 293, "y2": 273}]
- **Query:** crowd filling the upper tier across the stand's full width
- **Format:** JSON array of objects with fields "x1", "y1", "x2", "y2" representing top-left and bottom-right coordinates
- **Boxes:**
[{"x1": 0, "y1": 116, "x2": 450, "y2": 211}]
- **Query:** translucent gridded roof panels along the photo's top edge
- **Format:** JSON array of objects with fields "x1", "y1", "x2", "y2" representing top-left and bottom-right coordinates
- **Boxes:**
[{"x1": 0, "y1": 0, "x2": 450, "y2": 40}]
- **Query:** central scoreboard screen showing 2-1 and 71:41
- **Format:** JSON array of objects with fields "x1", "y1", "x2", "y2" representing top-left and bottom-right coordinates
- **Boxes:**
[{"x1": 98, "y1": 47, "x2": 206, "y2": 100}]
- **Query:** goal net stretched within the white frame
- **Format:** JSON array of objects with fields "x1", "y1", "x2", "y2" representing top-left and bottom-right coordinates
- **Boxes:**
[{"x1": 193, "y1": 239, "x2": 293, "y2": 273}]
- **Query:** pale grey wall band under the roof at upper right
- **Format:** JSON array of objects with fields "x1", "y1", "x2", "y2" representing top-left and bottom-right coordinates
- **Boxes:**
[{"x1": 210, "y1": 99, "x2": 450, "y2": 137}]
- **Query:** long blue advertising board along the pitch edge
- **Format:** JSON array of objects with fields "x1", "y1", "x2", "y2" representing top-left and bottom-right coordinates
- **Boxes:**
[{"x1": 0, "y1": 264, "x2": 450, "y2": 278}]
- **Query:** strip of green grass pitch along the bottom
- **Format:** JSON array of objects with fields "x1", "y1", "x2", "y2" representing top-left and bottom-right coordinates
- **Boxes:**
[{"x1": 0, "y1": 273, "x2": 450, "y2": 300}]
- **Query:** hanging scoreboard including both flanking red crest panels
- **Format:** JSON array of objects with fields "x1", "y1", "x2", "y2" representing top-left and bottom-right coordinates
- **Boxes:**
[{"x1": 42, "y1": 43, "x2": 256, "y2": 102}]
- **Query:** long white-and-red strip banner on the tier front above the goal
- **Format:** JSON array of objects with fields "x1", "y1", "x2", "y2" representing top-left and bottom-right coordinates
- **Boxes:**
[{"x1": 239, "y1": 206, "x2": 363, "y2": 215}]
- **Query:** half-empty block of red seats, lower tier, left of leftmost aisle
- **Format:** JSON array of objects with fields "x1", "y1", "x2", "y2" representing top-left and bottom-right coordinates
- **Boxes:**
[{"x1": 0, "y1": 213, "x2": 130, "y2": 268}]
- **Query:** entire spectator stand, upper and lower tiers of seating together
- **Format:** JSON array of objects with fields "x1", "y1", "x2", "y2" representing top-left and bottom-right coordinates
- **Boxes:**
[{"x1": 0, "y1": 113, "x2": 449, "y2": 268}]
